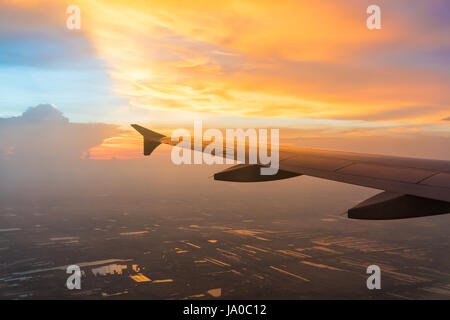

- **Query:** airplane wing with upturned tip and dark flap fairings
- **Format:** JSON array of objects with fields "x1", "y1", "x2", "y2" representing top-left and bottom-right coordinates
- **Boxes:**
[{"x1": 132, "y1": 125, "x2": 450, "y2": 220}]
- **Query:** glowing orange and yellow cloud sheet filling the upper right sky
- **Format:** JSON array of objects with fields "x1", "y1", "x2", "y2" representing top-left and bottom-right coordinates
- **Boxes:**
[{"x1": 4, "y1": 0, "x2": 450, "y2": 124}]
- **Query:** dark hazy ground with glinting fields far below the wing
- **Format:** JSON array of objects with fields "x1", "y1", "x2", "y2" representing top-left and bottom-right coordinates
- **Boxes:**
[{"x1": 0, "y1": 184, "x2": 450, "y2": 299}]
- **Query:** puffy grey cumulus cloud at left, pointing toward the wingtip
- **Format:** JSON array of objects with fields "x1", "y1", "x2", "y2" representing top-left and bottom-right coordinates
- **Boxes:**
[{"x1": 0, "y1": 104, "x2": 120, "y2": 161}]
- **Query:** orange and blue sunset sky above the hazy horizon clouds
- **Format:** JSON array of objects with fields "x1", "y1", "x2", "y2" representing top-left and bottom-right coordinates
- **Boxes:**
[{"x1": 0, "y1": 0, "x2": 450, "y2": 158}]
